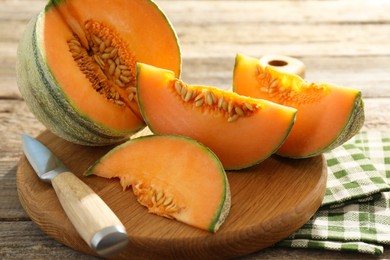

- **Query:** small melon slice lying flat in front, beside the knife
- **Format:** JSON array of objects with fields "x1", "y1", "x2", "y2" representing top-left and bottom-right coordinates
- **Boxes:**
[{"x1": 84, "y1": 135, "x2": 230, "y2": 232}]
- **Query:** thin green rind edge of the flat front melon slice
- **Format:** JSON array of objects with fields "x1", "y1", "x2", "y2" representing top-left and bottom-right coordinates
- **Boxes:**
[{"x1": 83, "y1": 135, "x2": 231, "y2": 233}]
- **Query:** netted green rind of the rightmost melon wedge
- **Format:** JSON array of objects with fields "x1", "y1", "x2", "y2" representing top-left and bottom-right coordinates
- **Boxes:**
[{"x1": 277, "y1": 91, "x2": 365, "y2": 159}]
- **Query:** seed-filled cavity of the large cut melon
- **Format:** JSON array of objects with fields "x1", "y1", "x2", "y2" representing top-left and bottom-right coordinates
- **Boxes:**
[{"x1": 67, "y1": 20, "x2": 136, "y2": 106}]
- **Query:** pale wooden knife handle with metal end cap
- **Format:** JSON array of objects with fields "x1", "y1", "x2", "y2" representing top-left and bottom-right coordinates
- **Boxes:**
[{"x1": 52, "y1": 172, "x2": 128, "y2": 256}]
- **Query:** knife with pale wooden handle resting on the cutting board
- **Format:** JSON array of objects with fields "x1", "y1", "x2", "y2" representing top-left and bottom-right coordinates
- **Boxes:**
[{"x1": 22, "y1": 134, "x2": 128, "y2": 257}]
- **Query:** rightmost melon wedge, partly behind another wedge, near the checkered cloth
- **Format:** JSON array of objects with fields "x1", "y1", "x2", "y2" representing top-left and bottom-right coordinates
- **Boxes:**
[{"x1": 233, "y1": 54, "x2": 364, "y2": 158}]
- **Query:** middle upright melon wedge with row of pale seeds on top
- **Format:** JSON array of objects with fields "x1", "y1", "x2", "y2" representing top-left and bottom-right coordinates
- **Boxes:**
[{"x1": 136, "y1": 63, "x2": 296, "y2": 170}]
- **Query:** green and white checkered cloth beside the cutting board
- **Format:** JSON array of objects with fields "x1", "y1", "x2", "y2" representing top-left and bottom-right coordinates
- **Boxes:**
[{"x1": 276, "y1": 131, "x2": 390, "y2": 255}]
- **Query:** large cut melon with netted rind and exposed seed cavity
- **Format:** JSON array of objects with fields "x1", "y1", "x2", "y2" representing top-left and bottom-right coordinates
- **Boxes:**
[{"x1": 17, "y1": 0, "x2": 181, "y2": 145}]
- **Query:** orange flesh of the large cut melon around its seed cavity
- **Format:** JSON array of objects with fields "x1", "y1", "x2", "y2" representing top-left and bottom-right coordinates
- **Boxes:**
[{"x1": 42, "y1": 0, "x2": 180, "y2": 131}]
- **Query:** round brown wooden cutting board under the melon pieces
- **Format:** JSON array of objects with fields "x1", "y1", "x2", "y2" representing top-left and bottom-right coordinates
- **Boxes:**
[{"x1": 16, "y1": 131, "x2": 327, "y2": 259}]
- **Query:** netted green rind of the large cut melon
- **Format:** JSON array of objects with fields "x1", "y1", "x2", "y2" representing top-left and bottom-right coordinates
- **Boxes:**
[{"x1": 16, "y1": 9, "x2": 144, "y2": 146}]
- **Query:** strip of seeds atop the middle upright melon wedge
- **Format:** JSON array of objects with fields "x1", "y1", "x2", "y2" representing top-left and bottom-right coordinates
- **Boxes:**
[{"x1": 172, "y1": 79, "x2": 261, "y2": 123}]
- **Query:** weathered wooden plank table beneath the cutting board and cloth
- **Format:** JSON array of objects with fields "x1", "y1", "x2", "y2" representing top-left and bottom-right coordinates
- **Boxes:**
[{"x1": 0, "y1": 0, "x2": 390, "y2": 259}]
